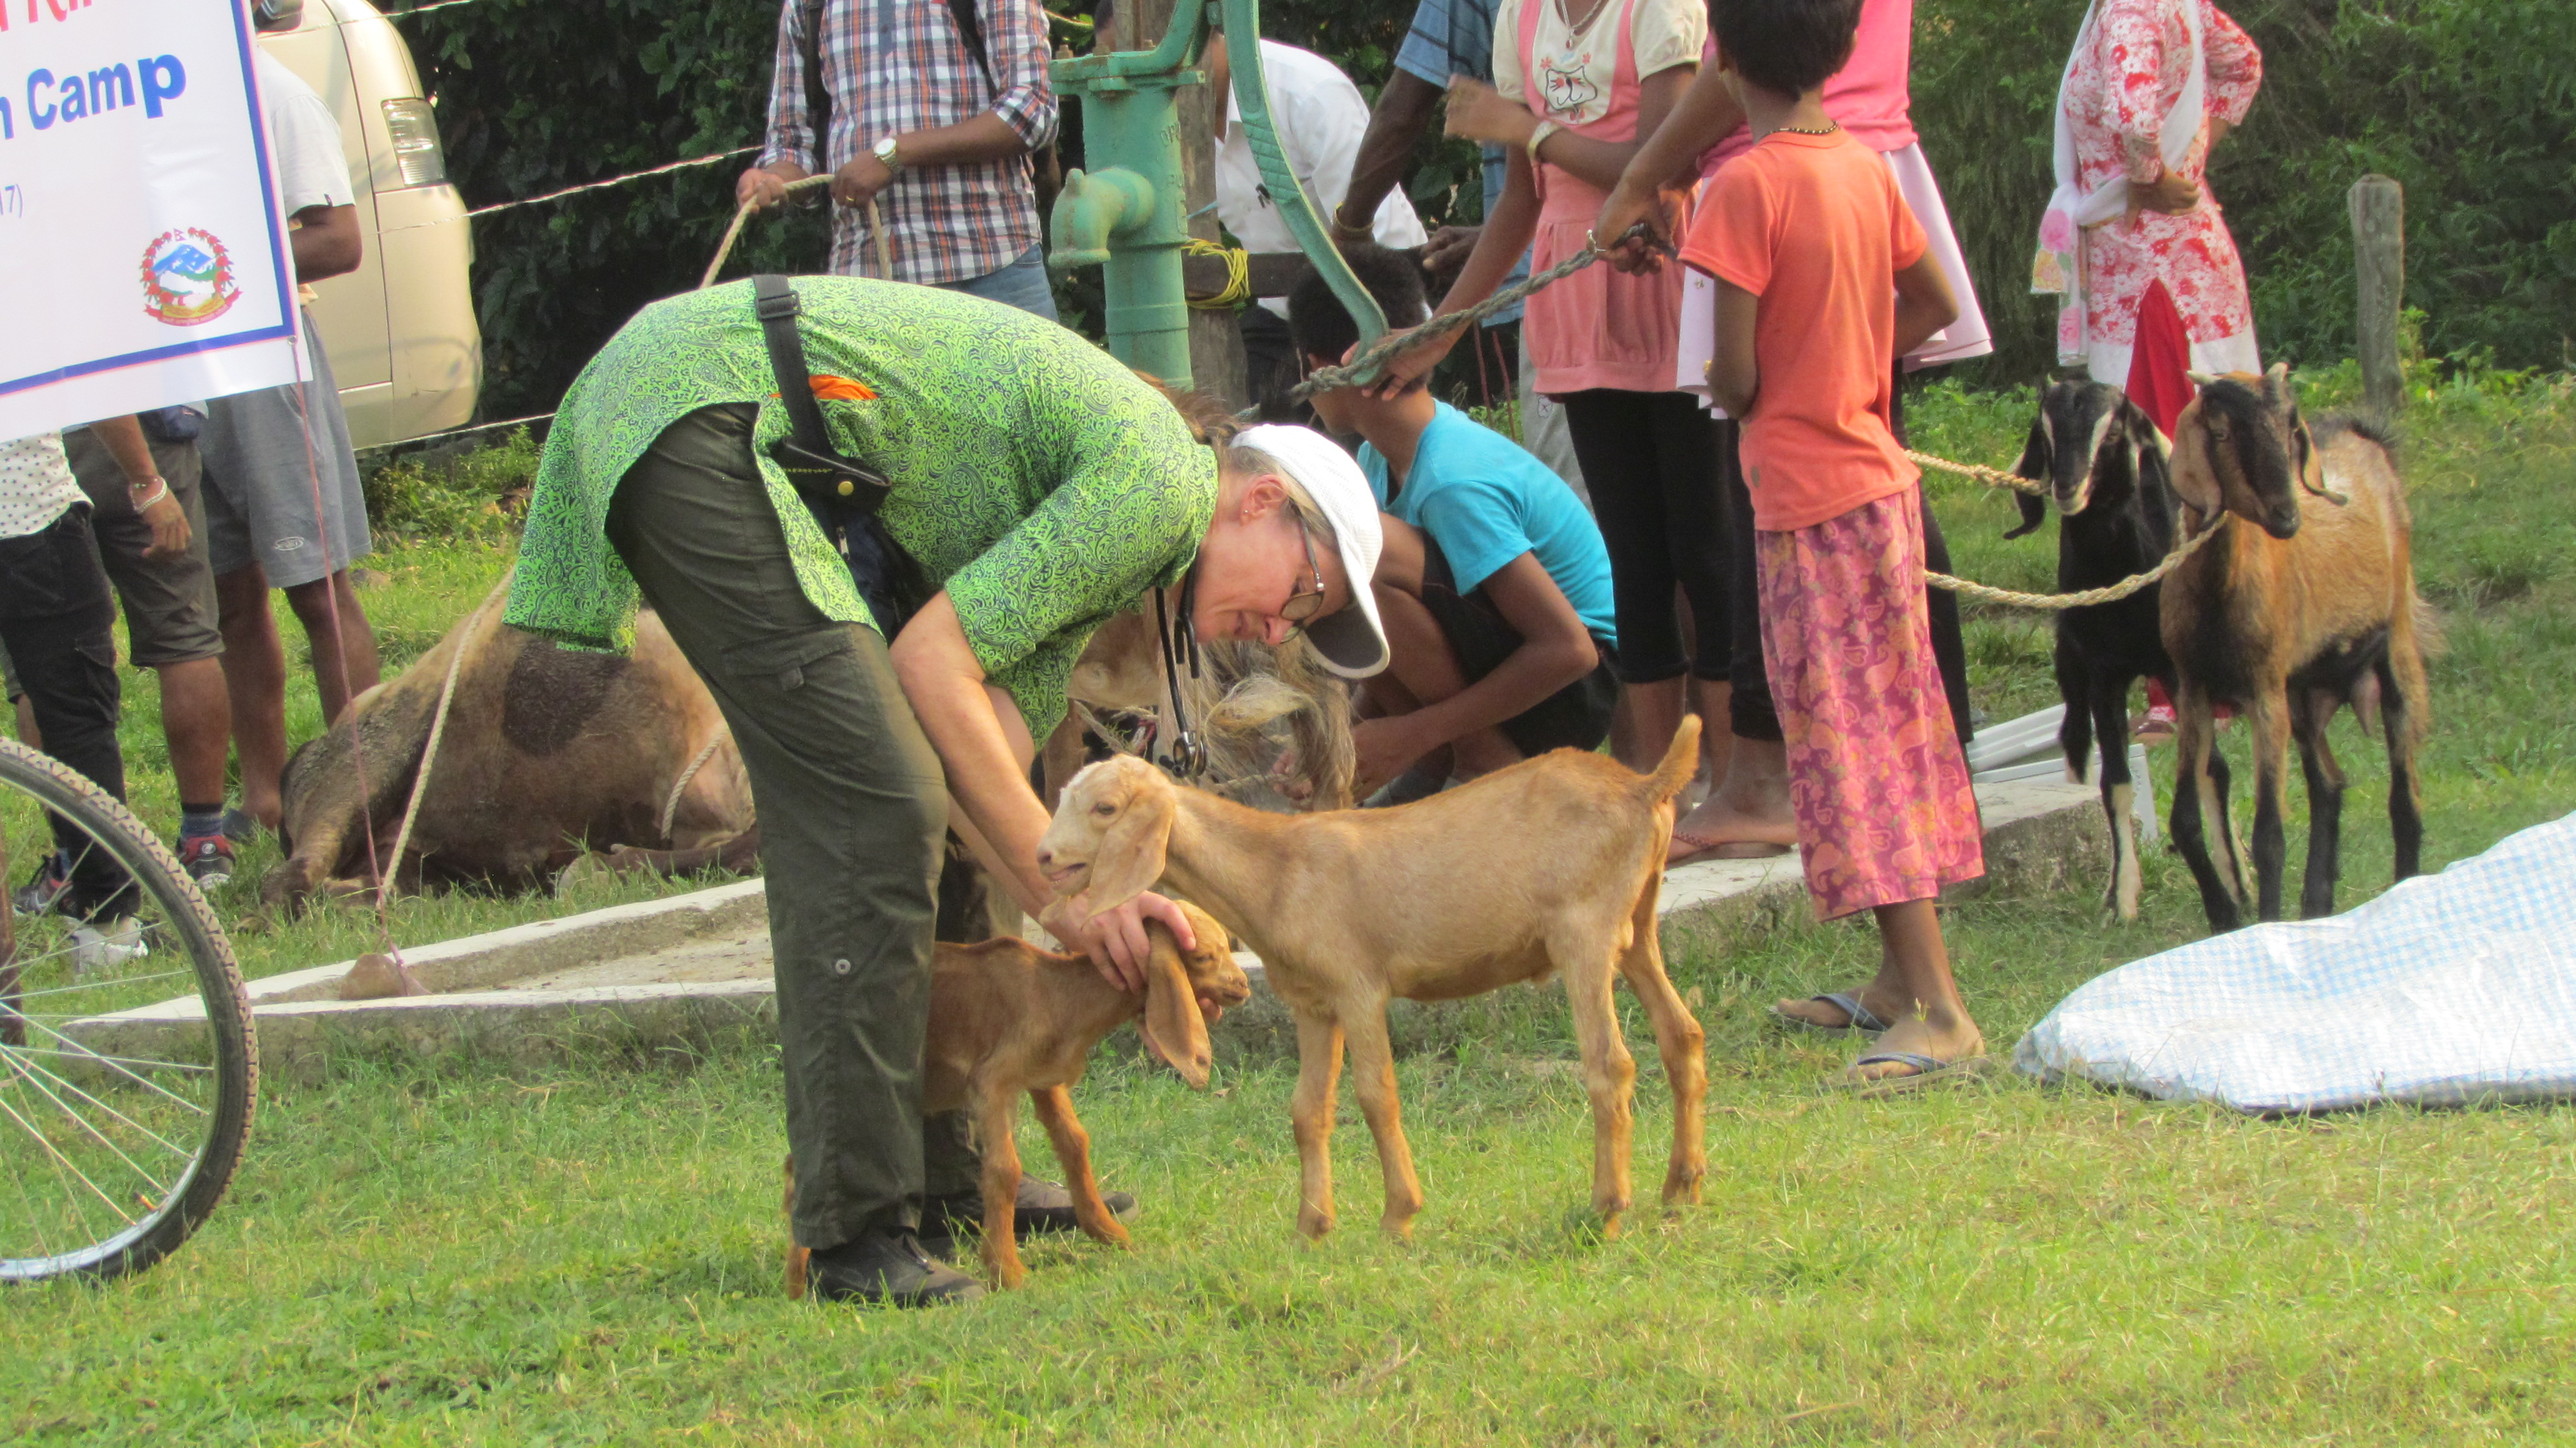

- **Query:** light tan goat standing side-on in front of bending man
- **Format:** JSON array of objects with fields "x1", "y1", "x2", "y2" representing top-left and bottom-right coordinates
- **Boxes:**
[{"x1": 1038, "y1": 719, "x2": 1708, "y2": 1237}]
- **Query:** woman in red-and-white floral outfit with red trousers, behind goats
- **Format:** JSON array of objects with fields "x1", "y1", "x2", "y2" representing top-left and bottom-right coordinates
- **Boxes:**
[{"x1": 2032, "y1": 0, "x2": 2262, "y2": 412}]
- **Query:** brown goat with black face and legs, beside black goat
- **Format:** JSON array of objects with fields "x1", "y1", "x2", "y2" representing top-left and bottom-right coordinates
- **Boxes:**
[{"x1": 2161, "y1": 366, "x2": 2440, "y2": 930}]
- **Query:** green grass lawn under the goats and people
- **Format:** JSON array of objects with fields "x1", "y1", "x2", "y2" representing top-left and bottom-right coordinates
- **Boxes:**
[{"x1": 0, "y1": 374, "x2": 2576, "y2": 1445}]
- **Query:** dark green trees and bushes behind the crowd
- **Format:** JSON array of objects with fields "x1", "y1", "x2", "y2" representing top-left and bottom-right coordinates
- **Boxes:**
[{"x1": 422, "y1": 0, "x2": 2576, "y2": 417}]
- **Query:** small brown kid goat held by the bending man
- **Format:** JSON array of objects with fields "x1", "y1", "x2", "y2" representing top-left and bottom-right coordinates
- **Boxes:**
[{"x1": 786, "y1": 904, "x2": 1252, "y2": 1299}]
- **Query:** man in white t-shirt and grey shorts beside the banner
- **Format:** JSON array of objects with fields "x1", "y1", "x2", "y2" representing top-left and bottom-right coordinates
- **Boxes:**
[{"x1": 201, "y1": 52, "x2": 378, "y2": 829}]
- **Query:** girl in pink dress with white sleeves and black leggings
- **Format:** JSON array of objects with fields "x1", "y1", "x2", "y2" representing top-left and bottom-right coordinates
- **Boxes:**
[{"x1": 1381, "y1": 0, "x2": 1734, "y2": 765}]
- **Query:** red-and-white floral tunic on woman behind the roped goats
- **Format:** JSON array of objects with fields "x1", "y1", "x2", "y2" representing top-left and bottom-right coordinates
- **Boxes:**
[{"x1": 2066, "y1": 0, "x2": 2262, "y2": 358}]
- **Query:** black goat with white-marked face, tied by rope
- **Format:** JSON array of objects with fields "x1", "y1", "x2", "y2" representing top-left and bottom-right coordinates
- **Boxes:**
[{"x1": 2004, "y1": 381, "x2": 2194, "y2": 920}]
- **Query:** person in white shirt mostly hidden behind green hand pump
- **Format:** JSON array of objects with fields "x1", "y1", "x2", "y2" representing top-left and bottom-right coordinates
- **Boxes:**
[{"x1": 1203, "y1": 36, "x2": 1427, "y2": 420}]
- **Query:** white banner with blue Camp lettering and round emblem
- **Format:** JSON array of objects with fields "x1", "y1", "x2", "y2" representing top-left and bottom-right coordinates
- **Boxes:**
[{"x1": 0, "y1": 0, "x2": 301, "y2": 438}]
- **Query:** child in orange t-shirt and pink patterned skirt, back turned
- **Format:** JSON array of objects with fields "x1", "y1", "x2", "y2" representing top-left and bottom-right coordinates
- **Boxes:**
[{"x1": 1682, "y1": 0, "x2": 1986, "y2": 1082}]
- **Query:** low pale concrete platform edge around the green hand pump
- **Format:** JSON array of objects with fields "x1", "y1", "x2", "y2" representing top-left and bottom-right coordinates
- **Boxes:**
[{"x1": 67, "y1": 778, "x2": 2107, "y2": 1080}]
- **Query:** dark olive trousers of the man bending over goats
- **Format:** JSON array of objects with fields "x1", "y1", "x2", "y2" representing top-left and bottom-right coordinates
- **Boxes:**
[{"x1": 608, "y1": 407, "x2": 981, "y2": 1250}]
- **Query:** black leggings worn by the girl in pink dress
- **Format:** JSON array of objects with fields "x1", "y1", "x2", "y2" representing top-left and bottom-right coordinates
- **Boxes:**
[{"x1": 1561, "y1": 389, "x2": 1720, "y2": 683}]
